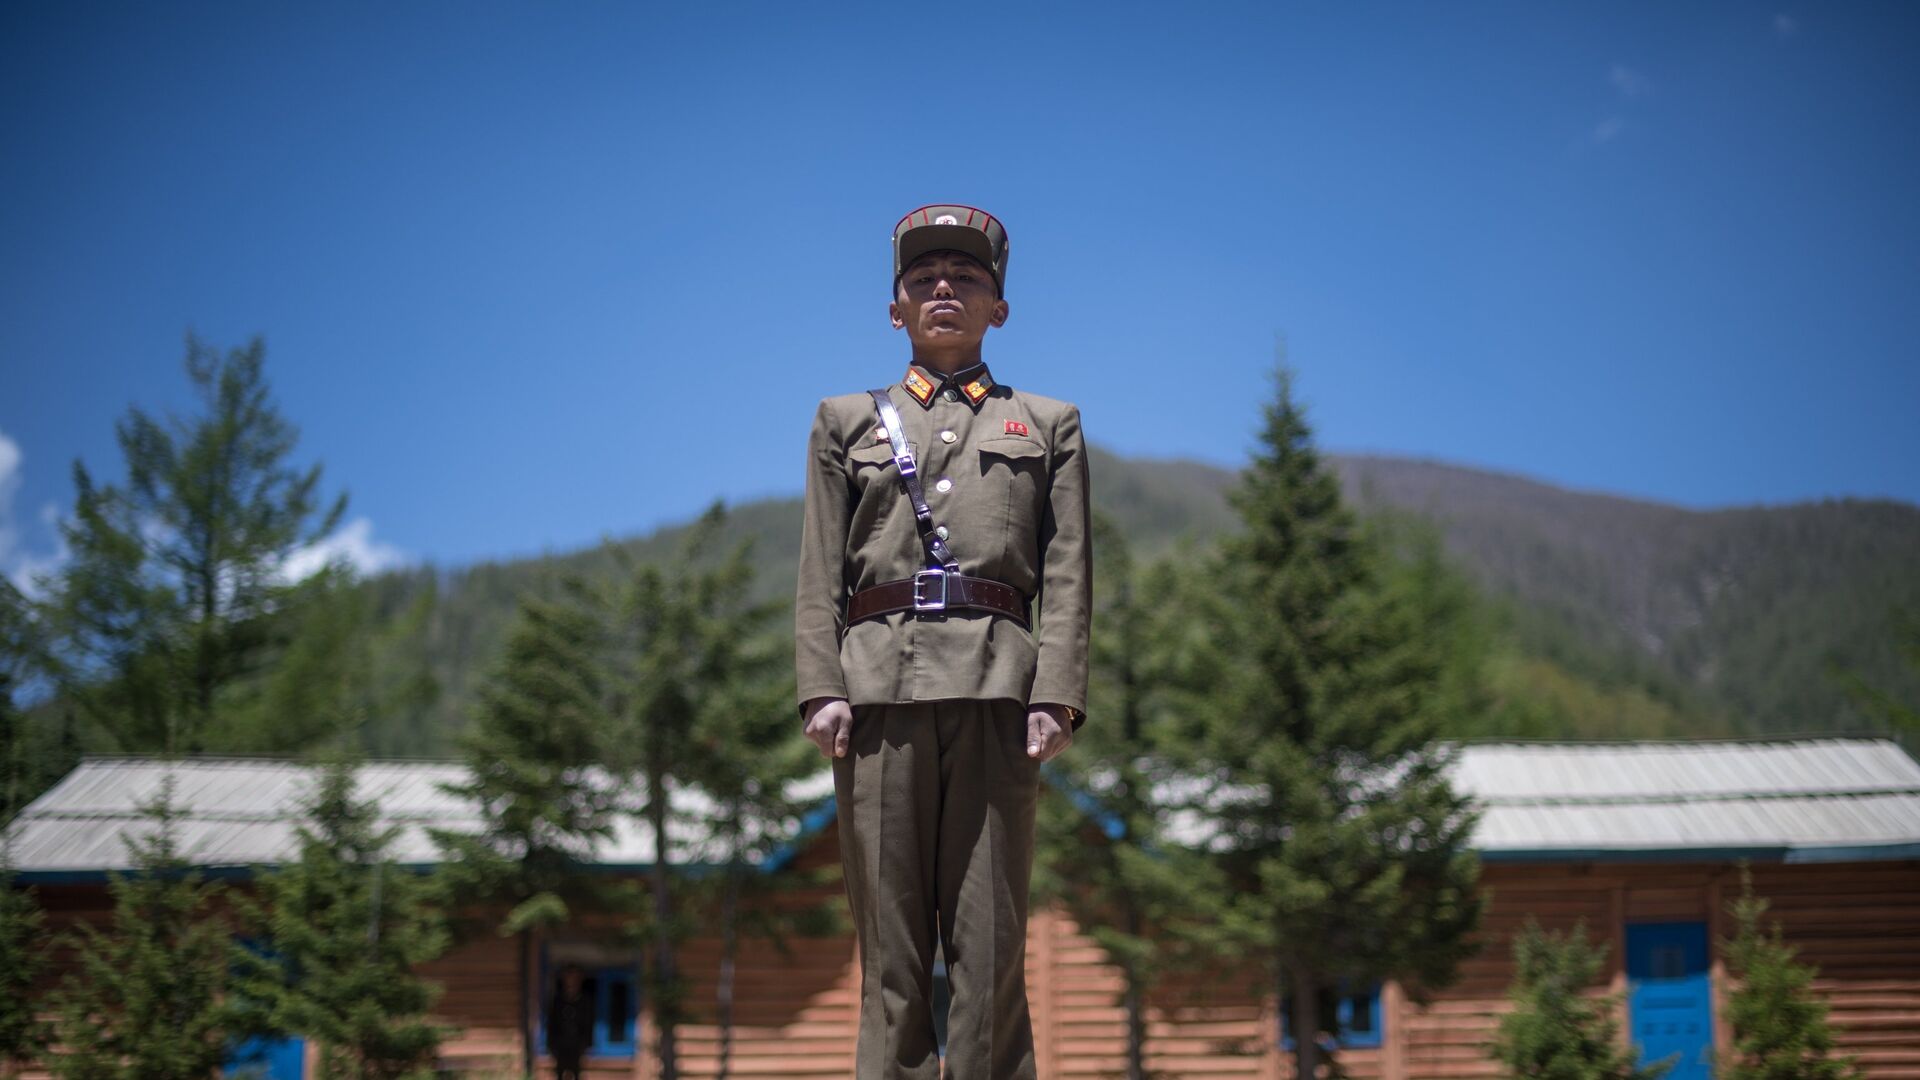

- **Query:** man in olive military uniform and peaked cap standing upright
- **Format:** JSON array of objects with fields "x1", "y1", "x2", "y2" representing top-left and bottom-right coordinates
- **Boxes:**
[{"x1": 795, "y1": 206, "x2": 1092, "y2": 1080}]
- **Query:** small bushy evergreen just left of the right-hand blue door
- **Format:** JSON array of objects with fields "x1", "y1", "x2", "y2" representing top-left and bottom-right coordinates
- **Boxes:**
[{"x1": 1488, "y1": 919, "x2": 1672, "y2": 1080}]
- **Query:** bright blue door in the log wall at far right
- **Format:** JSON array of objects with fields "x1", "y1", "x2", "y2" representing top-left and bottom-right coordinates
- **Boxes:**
[{"x1": 1626, "y1": 922, "x2": 1713, "y2": 1080}]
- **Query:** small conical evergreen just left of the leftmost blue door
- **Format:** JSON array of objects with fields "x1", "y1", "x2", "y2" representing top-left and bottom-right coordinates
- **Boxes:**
[{"x1": 50, "y1": 776, "x2": 236, "y2": 1080}]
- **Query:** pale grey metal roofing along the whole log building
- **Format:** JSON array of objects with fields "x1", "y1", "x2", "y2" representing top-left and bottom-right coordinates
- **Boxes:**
[{"x1": 8, "y1": 738, "x2": 1920, "y2": 878}]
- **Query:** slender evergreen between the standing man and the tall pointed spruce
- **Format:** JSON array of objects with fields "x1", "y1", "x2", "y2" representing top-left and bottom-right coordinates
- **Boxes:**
[{"x1": 1035, "y1": 515, "x2": 1219, "y2": 1080}]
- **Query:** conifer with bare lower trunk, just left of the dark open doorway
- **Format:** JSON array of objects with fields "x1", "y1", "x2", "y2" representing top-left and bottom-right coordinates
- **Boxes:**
[{"x1": 434, "y1": 578, "x2": 618, "y2": 1072}]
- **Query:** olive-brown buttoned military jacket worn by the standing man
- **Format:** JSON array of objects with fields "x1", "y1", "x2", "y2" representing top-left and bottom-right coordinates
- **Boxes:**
[{"x1": 793, "y1": 357, "x2": 1092, "y2": 711}]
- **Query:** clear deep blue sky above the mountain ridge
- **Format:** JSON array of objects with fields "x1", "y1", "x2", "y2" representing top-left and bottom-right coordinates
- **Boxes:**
[{"x1": 0, "y1": 2, "x2": 1920, "y2": 575}]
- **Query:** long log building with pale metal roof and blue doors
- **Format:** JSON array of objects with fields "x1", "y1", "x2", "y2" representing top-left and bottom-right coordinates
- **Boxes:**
[{"x1": 12, "y1": 738, "x2": 1920, "y2": 1080}]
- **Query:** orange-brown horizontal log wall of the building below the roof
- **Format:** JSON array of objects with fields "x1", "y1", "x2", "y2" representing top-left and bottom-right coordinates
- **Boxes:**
[{"x1": 27, "y1": 849, "x2": 1920, "y2": 1080}]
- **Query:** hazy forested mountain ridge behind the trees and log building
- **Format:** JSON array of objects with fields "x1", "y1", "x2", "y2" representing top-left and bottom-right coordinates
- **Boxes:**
[{"x1": 334, "y1": 441, "x2": 1920, "y2": 753}]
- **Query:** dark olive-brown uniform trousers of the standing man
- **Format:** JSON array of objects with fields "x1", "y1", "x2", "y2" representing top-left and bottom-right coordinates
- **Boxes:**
[{"x1": 833, "y1": 700, "x2": 1041, "y2": 1080}]
